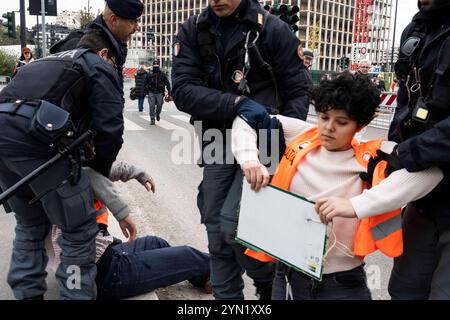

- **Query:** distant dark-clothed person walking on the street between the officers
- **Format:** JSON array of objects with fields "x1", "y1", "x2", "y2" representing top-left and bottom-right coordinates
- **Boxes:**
[{"x1": 146, "y1": 60, "x2": 171, "y2": 125}]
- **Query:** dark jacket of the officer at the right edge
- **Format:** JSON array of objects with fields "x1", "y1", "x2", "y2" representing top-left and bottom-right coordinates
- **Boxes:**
[{"x1": 389, "y1": 16, "x2": 450, "y2": 226}]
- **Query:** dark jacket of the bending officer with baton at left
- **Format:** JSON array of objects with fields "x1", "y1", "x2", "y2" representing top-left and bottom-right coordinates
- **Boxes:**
[{"x1": 0, "y1": 50, "x2": 124, "y2": 176}]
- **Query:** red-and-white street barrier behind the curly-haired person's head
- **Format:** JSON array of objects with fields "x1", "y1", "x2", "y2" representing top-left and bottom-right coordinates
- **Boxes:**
[{"x1": 308, "y1": 92, "x2": 397, "y2": 130}]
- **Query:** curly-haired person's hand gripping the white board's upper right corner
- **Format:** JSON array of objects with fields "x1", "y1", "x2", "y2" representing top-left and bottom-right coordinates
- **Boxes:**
[{"x1": 315, "y1": 197, "x2": 356, "y2": 224}]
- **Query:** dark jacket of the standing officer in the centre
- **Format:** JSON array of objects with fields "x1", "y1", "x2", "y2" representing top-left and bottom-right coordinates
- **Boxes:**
[{"x1": 172, "y1": 0, "x2": 309, "y2": 129}]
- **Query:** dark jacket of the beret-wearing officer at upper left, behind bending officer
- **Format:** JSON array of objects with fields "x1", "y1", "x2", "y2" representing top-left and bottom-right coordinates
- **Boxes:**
[{"x1": 50, "y1": 15, "x2": 128, "y2": 92}]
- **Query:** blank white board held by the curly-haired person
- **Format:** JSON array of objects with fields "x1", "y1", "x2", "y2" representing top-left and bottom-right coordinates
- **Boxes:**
[{"x1": 236, "y1": 180, "x2": 326, "y2": 281}]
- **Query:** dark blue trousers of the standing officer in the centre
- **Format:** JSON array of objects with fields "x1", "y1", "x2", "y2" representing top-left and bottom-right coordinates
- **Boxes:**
[{"x1": 197, "y1": 164, "x2": 275, "y2": 299}]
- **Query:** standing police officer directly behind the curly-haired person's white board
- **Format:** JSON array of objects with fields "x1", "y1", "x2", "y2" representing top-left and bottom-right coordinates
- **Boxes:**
[{"x1": 172, "y1": 0, "x2": 308, "y2": 299}]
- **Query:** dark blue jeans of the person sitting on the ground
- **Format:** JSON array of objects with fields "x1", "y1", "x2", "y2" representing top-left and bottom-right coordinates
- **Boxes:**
[{"x1": 96, "y1": 236, "x2": 210, "y2": 299}]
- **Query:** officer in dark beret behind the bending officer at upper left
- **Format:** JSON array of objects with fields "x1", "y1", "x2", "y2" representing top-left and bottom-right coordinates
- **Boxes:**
[{"x1": 50, "y1": 0, "x2": 144, "y2": 88}]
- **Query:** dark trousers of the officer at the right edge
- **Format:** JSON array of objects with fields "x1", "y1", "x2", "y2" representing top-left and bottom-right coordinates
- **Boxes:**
[{"x1": 389, "y1": 205, "x2": 450, "y2": 300}]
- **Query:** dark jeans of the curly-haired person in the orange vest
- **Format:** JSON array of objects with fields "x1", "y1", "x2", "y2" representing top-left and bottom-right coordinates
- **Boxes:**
[{"x1": 272, "y1": 262, "x2": 372, "y2": 300}]
